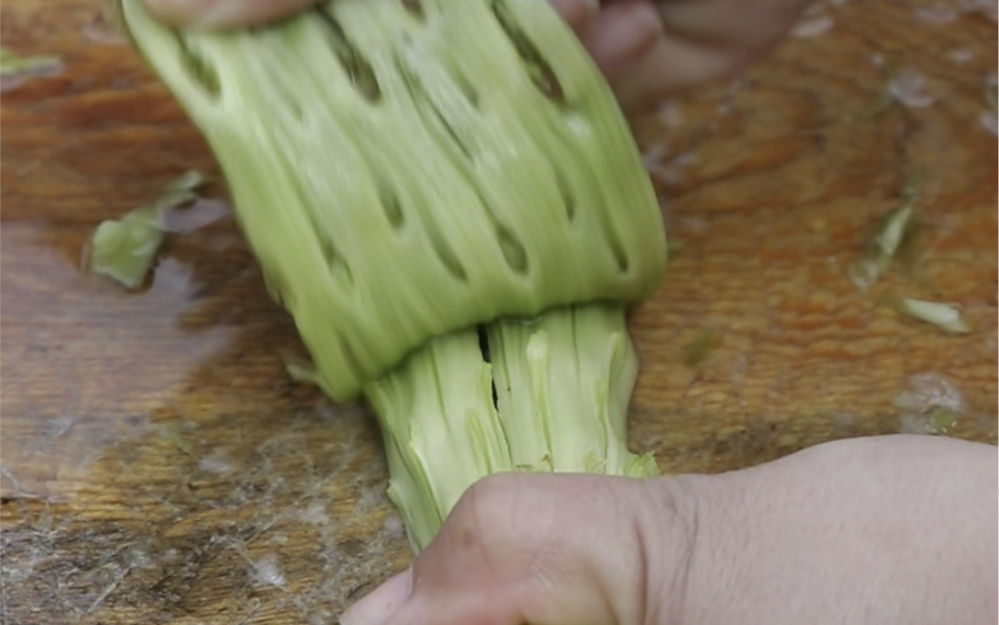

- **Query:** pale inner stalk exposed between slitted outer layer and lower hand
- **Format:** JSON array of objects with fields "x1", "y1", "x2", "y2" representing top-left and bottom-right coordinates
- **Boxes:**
[{"x1": 365, "y1": 304, "x2": 658, "y2": 550}]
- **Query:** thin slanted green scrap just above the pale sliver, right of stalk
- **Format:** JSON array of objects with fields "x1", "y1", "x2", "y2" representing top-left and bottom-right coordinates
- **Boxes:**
[{"x1": 849, "y1": 171, "x2": 923, "y2": 292}]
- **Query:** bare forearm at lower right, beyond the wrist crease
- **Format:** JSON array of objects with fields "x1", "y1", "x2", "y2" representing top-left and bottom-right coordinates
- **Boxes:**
[{"x1": 685, "y1": 436, "x2": 997, "y2": 624}]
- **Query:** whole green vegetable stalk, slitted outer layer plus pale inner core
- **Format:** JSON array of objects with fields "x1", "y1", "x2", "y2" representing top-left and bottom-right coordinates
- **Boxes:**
[{"x1": 121, "y1": 0, "x2": 666, "y2": 549}]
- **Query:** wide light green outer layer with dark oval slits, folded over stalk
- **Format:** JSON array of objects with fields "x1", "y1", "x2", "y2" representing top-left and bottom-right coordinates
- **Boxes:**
[{"x1": 123, "y1": 0, "x2": 666, "y2": 400}]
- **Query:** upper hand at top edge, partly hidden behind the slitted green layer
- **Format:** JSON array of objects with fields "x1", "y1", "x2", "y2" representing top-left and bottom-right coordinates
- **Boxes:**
[{"x1": 139, "y1": 0, "x2": 810, "y2": 112}]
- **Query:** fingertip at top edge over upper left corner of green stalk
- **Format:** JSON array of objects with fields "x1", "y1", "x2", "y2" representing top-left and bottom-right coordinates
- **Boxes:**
[{"x1": 146, "y1": 0, "x2": 318, "y2": 28}]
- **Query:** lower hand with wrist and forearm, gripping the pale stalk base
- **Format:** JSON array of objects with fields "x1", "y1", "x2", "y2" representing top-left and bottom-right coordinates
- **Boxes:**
[{"x1": 341, "y1": 436, "x2": 997, "y2": 625}]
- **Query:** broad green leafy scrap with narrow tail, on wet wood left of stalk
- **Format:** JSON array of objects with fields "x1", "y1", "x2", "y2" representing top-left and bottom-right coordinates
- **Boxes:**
[{"x1": 87, "y1": 170, "x2": 208, "y2": 290}]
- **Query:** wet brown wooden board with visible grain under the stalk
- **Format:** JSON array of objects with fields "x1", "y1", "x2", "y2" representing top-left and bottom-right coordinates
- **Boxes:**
[{"x1": 0, "y1": 0, "x2": 997, "y2": 625}]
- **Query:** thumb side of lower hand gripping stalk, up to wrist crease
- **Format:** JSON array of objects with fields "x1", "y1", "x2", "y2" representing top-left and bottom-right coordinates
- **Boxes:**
[{"x1": 341, "y1": 474, "x2": 690, "y2": 625}]
